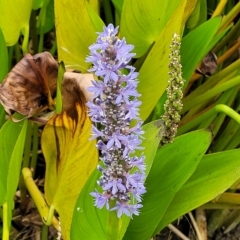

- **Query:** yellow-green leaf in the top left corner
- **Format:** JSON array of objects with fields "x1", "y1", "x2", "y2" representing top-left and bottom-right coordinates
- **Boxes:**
[{"x1": 0, "y1": 0, "x2": 32, "y2": 51}]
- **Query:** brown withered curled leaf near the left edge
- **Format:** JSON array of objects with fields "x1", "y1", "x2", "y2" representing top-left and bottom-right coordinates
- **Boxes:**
[{"x1": 0, "y1": 52, "x2": 58, "y2": 117}]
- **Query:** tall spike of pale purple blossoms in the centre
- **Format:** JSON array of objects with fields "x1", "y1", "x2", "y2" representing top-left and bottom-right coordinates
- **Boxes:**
[{"x1": 86, "y1": 24, "x2": 146, "y2": 217}]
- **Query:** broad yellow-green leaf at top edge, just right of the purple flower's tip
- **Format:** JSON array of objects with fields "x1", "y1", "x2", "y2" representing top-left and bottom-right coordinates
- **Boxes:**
[{"x1": 121, "y1": 0, "x2": 183, "y2": 57}]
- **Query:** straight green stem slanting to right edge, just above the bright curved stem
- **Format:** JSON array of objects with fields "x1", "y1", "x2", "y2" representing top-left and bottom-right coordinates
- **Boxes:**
[{"x1": 182, "y1": 76, "x2": 240, "y2": 113}]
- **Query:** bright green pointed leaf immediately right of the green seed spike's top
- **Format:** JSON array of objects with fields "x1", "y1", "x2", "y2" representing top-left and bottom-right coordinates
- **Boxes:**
[{"x1": 181, "y1": 17, "x2": 221, "y2": 83}]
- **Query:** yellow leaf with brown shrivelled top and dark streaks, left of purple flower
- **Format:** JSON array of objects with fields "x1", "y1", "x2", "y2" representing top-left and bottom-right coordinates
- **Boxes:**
[{"x1": 42, "y1": 78, "x2": 98, "y2": 240}]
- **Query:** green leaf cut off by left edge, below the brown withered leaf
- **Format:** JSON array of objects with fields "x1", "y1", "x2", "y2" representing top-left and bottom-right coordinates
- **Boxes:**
[{"x1": 0, "y1": 115, "x2": 22, "y2": 206}]
